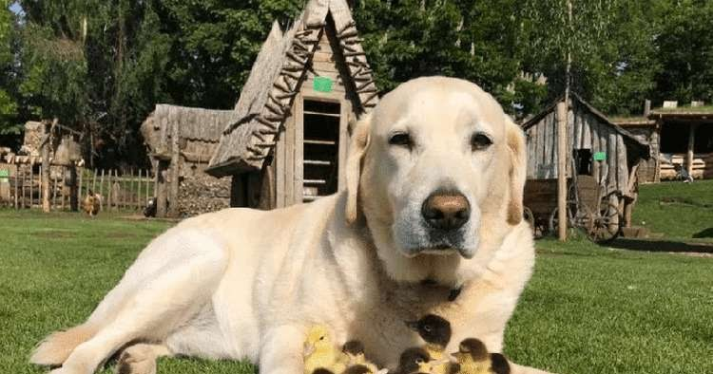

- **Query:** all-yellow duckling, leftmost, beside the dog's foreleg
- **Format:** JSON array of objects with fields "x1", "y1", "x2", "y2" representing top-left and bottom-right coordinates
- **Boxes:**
[{"x1": 304, "y1": 325, "x2": 345, "y2": 374}]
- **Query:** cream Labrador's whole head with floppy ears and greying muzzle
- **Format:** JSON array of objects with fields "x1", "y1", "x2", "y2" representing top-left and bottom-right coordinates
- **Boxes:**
[{"x1": 346, "y1": 77, "x2": 526, "y2": 284}]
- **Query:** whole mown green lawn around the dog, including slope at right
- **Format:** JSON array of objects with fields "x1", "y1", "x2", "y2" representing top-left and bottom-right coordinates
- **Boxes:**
[{"x1": 0, "y1": 187, "x2": 713, "y2": 374}]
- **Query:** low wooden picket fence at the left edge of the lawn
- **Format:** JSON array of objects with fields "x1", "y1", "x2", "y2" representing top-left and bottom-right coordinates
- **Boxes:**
[{"x1": 0, "y1": 165, "x2": 155, "y2": 211}]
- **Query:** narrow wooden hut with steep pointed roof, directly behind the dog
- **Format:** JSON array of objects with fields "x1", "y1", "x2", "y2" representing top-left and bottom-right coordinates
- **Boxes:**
[{"x1": 207, "y1": 0, "x2": 378, "y2": 209}]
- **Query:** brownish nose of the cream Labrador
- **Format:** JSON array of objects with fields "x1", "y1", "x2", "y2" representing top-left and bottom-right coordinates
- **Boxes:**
[{"x1": 421, "y1": 191, "x2": 470, "y2": 231}]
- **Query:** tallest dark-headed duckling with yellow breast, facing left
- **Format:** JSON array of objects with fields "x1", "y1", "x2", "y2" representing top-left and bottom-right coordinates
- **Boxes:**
[{"x1": 406, "y1": 314, "x2": 452, "y2": 374}]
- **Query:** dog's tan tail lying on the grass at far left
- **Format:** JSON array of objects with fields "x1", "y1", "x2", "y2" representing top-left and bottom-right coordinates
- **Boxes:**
[{"x1": 30, "y1": 323, "x2": 99, "y2": 366}]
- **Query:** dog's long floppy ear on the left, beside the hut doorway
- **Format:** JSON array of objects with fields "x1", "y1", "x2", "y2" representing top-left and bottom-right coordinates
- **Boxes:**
[{"x1": 346, "y1": 114, "x2": 371, "y2": 224}]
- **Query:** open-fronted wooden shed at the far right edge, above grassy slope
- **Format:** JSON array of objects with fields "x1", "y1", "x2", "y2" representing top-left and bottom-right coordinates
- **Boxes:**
[{"x1": 649, "y1": 107, "x2": 713, "y2": 181}]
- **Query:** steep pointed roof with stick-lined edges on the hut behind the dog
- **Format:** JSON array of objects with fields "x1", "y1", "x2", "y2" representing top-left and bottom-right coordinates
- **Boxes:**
[{"x1": 207, "y1": 0, "x2": 378, "y2": 177}]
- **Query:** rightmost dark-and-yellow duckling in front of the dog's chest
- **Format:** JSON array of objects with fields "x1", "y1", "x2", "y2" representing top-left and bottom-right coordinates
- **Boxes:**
[{"x1": 452, "y1": 338, "x2": 510, "y2": 374}]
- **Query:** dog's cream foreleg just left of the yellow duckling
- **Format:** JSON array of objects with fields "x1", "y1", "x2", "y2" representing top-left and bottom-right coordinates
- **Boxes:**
[{"x1": 260, "y1": 326, "x2": 305, "y2": 374}]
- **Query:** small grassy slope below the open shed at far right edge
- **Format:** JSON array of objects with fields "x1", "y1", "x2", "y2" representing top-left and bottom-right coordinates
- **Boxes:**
[{"x1": 632, "y1": 180, "x2": 713, "y2": 242}]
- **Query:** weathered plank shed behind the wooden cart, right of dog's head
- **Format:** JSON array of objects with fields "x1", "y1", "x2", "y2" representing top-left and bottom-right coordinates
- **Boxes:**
[{"x1": 522, "y1": 94, "x2": 649, "y2": 223}]
